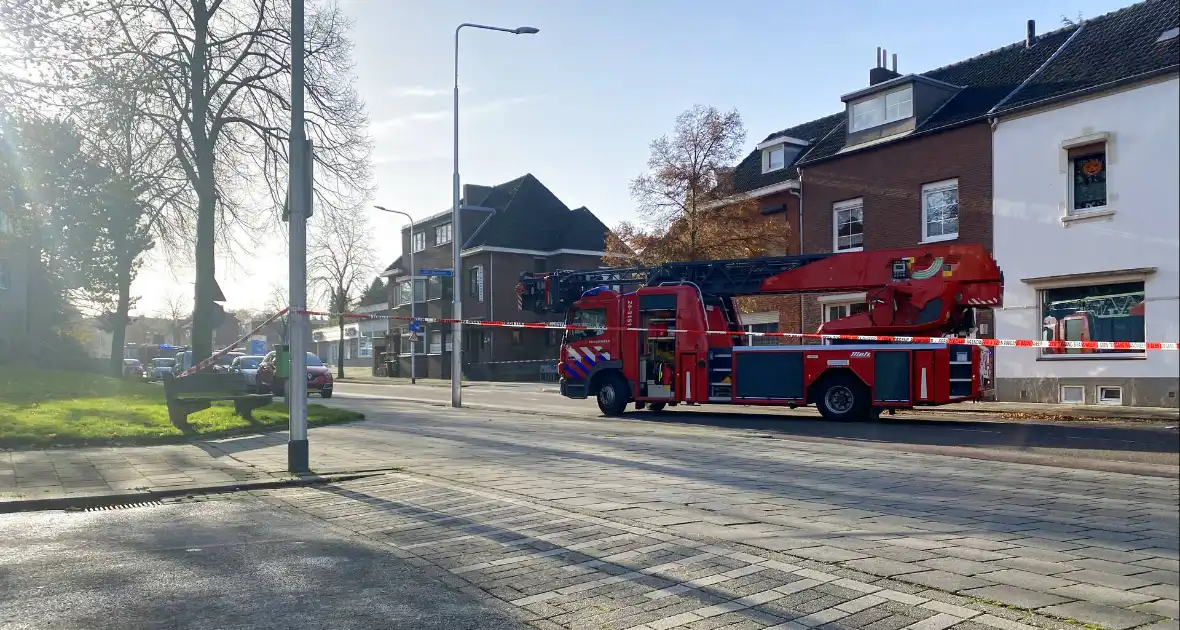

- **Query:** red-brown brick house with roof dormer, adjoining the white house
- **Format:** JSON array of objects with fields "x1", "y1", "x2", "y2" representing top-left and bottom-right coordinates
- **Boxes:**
[{"x1": 739, "y1": 18, "x2": 1074, "y2": 351}]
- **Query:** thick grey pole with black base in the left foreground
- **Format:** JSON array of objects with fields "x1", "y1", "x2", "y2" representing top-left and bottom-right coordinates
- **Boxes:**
[{"x1": 287, "y1": 0, "x2": 312, "y2": 473}]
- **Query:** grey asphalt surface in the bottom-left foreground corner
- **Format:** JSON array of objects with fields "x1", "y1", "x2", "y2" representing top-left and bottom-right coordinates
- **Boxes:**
[{"x1": 0, "y1": 498, "x2": 524, "y2": 630}]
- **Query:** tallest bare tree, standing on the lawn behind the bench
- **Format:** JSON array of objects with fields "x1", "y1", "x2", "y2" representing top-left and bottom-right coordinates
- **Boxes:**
[{"x1": 0, "y1": 0, "x2": 372, "y2": 360}]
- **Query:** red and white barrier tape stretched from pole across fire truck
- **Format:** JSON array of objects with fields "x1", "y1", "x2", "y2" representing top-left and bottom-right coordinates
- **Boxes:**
[{"x1": 297, "y1": 310, "x2": 1180, "y2": 352}]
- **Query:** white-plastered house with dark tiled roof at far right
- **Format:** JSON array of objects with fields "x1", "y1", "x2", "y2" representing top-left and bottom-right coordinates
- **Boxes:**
[{"x1": 992, "y1": 7, "x2": 1180, "y2": 407}]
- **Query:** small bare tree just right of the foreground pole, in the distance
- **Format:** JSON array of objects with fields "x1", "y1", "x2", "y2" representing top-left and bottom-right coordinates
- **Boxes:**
[{"x1": 308, "y1": 210, "x2": 376, "y2": 379}]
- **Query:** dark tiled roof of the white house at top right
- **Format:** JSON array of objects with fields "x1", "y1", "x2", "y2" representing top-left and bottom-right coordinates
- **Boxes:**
[{"x1": 999, "y1": 0, "x2": 1180, "y2": 111}]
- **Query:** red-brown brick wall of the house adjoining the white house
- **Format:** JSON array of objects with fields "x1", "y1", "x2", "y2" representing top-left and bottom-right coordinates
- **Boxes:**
[{"x1": 801, "y1": 123, "x2": 994, "y2": 336}]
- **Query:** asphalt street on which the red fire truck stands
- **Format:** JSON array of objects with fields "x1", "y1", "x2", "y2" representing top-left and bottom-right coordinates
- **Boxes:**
[{"x1": 330, "y1": 383, "x2": 1180, "y2": 477}]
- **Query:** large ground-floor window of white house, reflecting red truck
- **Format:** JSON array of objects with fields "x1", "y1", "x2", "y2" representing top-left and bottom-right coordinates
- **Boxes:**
[{"x1": 1041, "y1": 282, "x2": 1146, "y2": 357}]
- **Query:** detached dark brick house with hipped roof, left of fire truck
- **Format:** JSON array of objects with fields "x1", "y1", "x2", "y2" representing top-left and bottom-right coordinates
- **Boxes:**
[{"x1": 381, "y1": 175, "x2": 609, "y2": 380}]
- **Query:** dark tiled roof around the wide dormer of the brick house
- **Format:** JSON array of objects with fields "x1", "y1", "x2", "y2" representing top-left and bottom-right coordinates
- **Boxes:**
[{"x1": 799, "y1": 26, "x2": 1077, "y2": 165}]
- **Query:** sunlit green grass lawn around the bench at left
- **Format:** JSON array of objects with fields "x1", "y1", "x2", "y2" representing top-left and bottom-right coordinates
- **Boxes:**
[{"x1": 0, "y1": 366, "x2": 365, "y2": 449}]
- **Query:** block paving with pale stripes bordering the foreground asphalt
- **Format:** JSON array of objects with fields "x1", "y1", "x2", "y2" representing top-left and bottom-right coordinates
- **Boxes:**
[{"x1": 257, "y1": 474, "x2": 1175, "y2": 630}]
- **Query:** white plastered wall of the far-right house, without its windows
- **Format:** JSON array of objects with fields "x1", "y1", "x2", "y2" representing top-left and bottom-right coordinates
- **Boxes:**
[{"x1": 992, "y1": 79, "x2": 1180, "y2": 379}]
